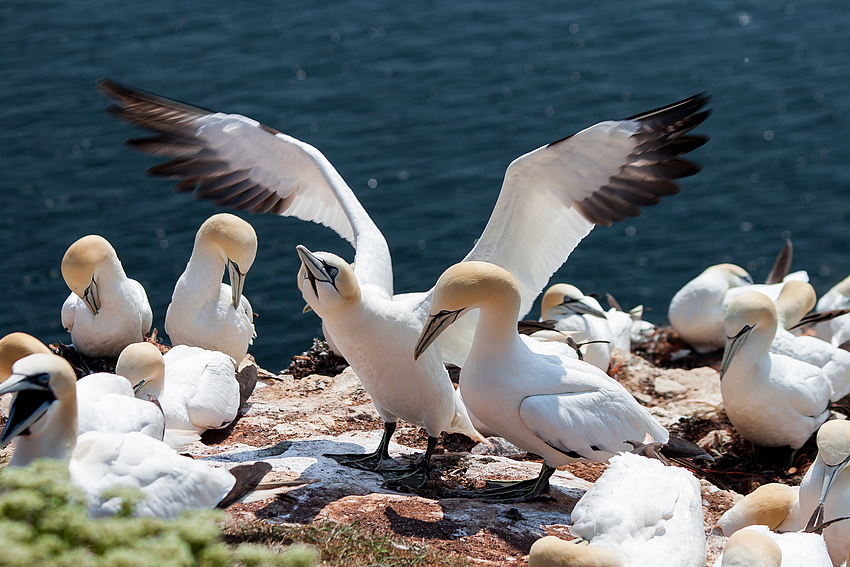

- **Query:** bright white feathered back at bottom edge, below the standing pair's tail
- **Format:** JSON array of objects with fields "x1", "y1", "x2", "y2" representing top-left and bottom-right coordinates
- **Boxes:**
[{"x1": 570, "y1": 453, "x2": 706, "y2": 567}]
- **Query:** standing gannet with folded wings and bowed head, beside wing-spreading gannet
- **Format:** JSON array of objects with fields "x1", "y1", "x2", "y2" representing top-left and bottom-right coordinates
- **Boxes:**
[{"x1": 414, "y1": 262, "x2": 669, "y2": 498}]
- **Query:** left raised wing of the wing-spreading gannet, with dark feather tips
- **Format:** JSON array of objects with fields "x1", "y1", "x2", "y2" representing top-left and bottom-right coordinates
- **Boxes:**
[{"x1": 97, "y1": 79, "x2": 392, "y2": 294}]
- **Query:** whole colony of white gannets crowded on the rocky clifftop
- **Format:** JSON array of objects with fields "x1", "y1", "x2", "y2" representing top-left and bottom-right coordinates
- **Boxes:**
[{"x1": 0, "y1": 79, "x2": 850, "y2": 567}]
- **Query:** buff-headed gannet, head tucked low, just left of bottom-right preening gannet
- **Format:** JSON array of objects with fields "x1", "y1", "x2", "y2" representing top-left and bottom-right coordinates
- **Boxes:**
[{"x1": 717, "y1": 482, "x2": 803, "y2": 536}]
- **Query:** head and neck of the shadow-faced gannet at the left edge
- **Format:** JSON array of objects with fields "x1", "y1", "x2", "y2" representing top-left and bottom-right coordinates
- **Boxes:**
[{"x1": 0, "y1": 353, "x2": 77, "y2": 466}]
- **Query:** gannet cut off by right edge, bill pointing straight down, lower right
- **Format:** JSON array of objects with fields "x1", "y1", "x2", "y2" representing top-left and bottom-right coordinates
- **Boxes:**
[{"x1": 800, "y1": 420, "x2": 850, "y2": 567}]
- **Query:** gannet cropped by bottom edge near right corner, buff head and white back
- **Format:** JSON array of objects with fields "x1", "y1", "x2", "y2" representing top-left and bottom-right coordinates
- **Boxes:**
[{"x1": 714, "y1": 525, "x2": 832, "y2": 567}]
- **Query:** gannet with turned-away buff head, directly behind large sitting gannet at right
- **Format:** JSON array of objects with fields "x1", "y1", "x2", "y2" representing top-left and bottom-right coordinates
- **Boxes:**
[{"x1": 770, "y1": 281, "x2": 850, "y2": 401}]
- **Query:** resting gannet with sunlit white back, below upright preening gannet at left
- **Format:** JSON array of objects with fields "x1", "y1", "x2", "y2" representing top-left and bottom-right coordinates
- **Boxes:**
[{"x1": 122, "y1": 343, "x2": 240, "y2": 447}]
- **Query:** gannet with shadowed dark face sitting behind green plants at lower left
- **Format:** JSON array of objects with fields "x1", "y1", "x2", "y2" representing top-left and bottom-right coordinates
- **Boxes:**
[{"x1": 0, "y1": 353, "x2": 296, "y2": 518}]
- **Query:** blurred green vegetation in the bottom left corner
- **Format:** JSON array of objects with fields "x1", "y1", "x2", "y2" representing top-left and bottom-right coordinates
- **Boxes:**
[{"x1": 0, "y1": 461, "x2": 316, "y2": 567}]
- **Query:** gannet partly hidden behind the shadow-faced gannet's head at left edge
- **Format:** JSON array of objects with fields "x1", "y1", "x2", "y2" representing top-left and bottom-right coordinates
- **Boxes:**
[{"x1": 0, "y1": 333, "x2": 165, "y2": 440}]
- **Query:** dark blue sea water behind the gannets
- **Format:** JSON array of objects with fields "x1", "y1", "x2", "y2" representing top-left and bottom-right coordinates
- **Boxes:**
[{"x1": 0, "y1": 0, "x2": 850, "y2": 370}]
